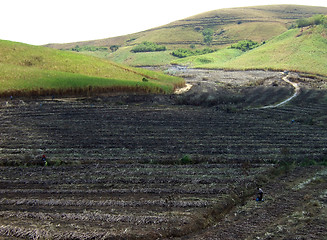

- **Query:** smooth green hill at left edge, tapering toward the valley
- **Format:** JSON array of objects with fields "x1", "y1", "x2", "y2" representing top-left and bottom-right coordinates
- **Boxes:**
[{"x1": 0, "y1": 40, "x2": 184, "y2": 95}]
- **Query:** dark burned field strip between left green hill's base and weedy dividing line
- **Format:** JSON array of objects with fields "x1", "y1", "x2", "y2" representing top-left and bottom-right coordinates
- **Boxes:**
[{"x1": 0, "y1": 98, "x2": 326, "y2": 166}]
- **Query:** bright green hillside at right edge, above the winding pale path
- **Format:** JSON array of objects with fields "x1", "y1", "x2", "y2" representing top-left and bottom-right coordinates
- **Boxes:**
[{"x1": 187, "y1": 25, "x2": 327, "y2": 76}]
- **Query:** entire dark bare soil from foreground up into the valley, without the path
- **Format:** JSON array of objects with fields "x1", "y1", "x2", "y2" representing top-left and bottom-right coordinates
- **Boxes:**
[{"x1": 0, "y1": 70, "x2": 327, "y2": 239}]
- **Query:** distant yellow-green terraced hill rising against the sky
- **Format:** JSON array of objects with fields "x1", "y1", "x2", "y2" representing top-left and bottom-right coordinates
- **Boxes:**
[{"x1": 47, "y1": 5, "x2": 327, "y2": 66}]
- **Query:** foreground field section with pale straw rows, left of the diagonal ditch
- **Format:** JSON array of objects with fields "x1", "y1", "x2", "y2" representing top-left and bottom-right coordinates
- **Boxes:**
[{"x1": 0, "y1": 164, "x2": 266, "y2": 239}]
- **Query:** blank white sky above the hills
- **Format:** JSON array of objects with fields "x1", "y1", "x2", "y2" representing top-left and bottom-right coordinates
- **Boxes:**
[{"x1": 0, "y1": 0, "x2": 327, "y2": 45}]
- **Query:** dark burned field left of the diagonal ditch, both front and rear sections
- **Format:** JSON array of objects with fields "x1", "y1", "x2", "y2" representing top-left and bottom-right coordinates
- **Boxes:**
[{"x1": 0, "y1": 69, "x2": 327, "y2": 239}]
